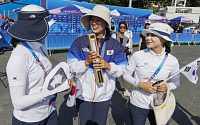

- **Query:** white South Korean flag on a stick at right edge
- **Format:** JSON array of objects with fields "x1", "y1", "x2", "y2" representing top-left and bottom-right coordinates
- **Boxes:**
[{"x1": 180, "y1": 58, "x2": 200, "y2": 84}]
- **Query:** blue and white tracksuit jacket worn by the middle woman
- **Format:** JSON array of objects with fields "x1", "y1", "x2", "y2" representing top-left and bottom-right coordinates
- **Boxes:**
[{"x1": 67, "y1": 36, "x2": 127, "y2": 102}]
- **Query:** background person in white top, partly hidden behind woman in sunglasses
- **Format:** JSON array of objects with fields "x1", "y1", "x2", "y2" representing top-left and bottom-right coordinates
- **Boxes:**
[{"x1": 124, "y1": 22, "x2": 133, "y2": 57}]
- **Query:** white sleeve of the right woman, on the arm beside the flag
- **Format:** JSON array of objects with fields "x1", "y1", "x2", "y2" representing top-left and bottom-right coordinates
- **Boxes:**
[{"x1": 168, "y1": 60, "x2": 180, "y2": 90}]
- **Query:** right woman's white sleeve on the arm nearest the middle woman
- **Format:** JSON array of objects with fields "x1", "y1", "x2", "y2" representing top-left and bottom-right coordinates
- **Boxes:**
[{"x1": 123, "y1": 54, "x2": 140, "y2": 88}]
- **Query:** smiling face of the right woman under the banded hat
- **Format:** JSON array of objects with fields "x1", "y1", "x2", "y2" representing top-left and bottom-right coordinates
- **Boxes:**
[{"x1": 145, "y1": 33, "x2": 166, "y2": 54}]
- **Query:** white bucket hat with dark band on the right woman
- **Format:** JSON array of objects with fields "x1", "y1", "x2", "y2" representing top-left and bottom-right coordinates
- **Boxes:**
[{"x1": 142, "y1": 23, "x2": 172, "y2": 42}]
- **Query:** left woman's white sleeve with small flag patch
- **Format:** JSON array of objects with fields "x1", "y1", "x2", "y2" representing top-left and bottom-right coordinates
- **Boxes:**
[{"x1": 6, "y1": 56, "x2": 52, "y2": 110}]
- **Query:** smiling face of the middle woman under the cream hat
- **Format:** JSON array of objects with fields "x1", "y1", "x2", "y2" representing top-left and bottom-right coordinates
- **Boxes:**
[{"x1": 90, "y1": 16, "x2": 108, "y2": 38}]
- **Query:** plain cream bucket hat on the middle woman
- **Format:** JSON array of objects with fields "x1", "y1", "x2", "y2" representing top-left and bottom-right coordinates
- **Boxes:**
[{"x1": 81, "y1": 5, "x2": 111, "y2": 30}]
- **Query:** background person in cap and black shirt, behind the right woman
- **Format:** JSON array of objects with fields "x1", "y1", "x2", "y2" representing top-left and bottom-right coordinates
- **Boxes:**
[{"x1": 138, "y1": 20, "x2": 151, "y2": 51}]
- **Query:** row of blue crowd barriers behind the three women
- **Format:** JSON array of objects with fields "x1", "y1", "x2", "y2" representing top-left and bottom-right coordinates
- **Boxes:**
[{"x1": 0, "y1": 30, "x2": 200, "y2": 50}]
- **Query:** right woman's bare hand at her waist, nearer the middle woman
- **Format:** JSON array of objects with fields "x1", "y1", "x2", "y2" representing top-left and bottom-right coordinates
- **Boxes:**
[{"x1": 138, "y1": 82, "x2": 157, "y2": 94}]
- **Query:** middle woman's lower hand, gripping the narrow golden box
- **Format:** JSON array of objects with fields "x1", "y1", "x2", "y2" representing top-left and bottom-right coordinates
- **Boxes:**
[{"x1": 93, "y1": 55, "x2": 111, "y2": 70}]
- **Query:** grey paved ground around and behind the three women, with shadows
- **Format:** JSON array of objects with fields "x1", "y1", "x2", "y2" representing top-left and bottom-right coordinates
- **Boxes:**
[{"x1": 0, "y1": 45, "x2": 200, "y2": 125}]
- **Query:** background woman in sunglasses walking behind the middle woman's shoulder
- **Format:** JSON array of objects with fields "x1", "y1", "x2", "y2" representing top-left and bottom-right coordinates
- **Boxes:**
[{"x1": 112, "y1": 22, "x2": 131, "y2": 96}]
